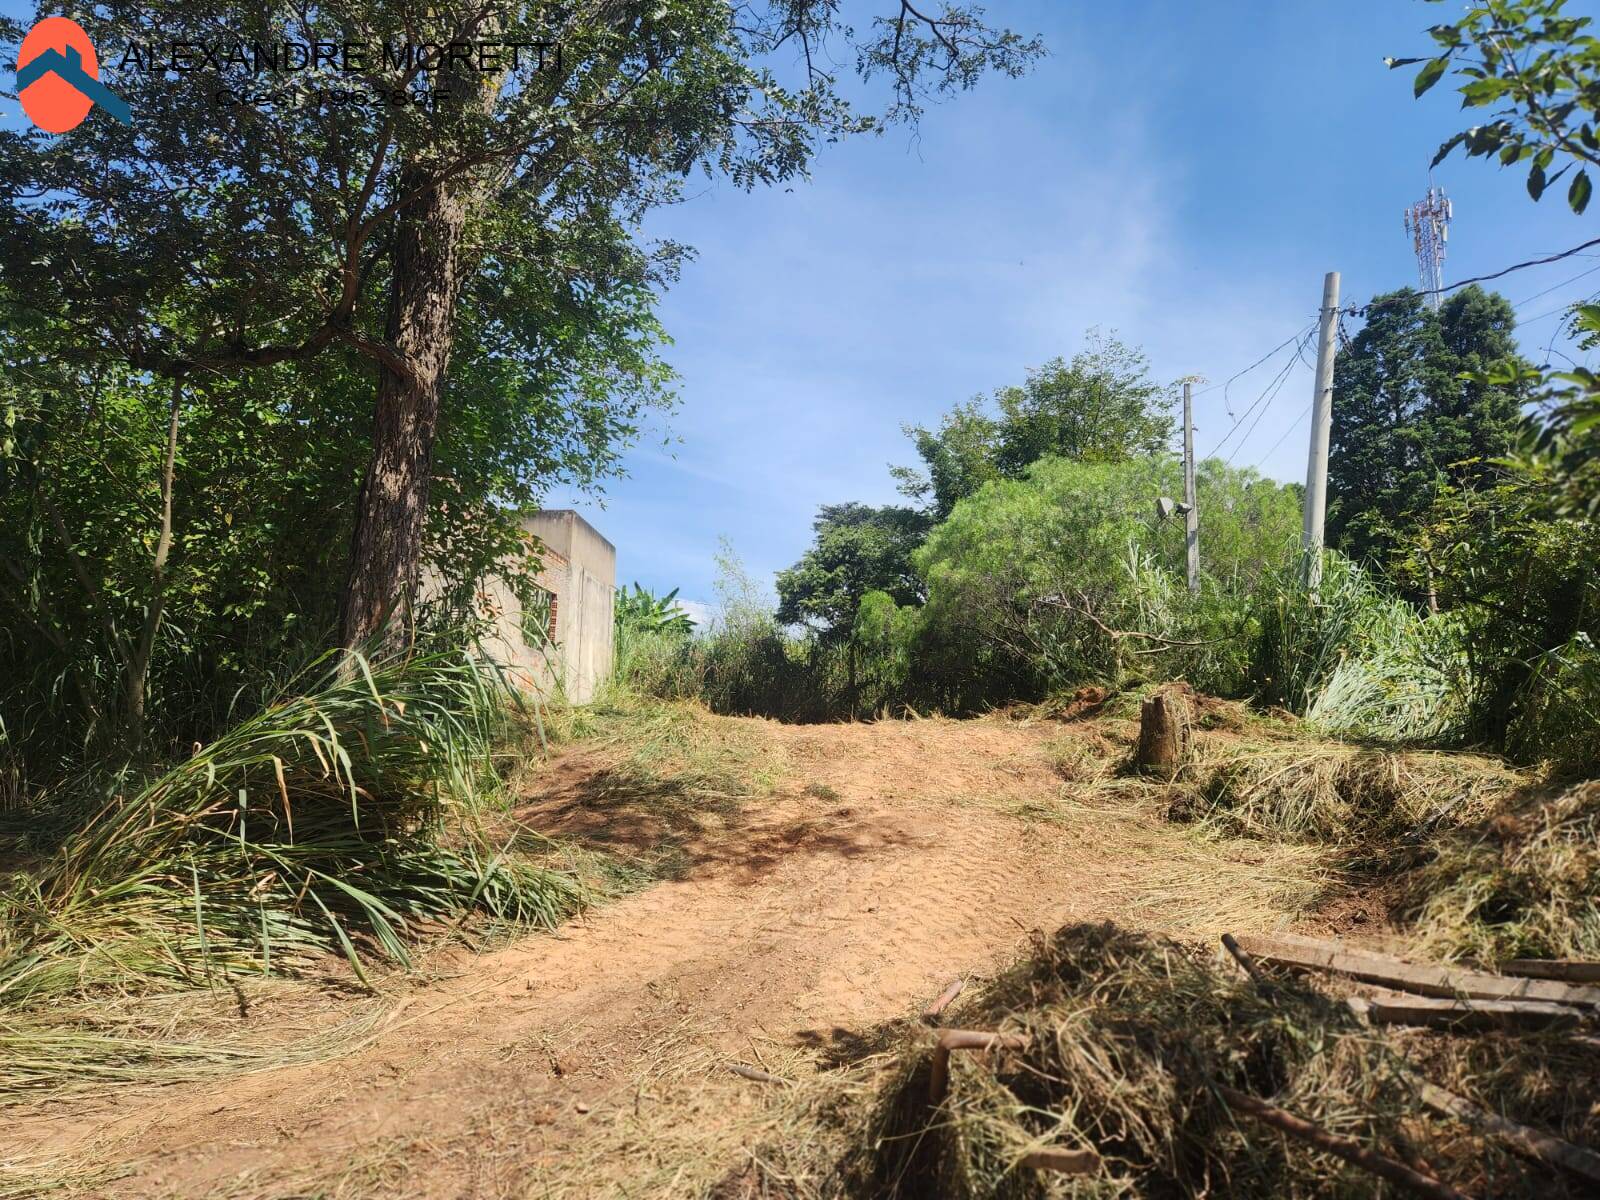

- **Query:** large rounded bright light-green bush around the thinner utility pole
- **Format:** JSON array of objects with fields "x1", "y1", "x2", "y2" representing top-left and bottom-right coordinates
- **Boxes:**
[{"x1": 917, "y1": 458, "x2": 1299, "y2": 707}]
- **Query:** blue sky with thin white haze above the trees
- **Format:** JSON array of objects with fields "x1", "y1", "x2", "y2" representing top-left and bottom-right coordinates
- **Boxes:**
[{"x1": 550, "y1": 0, "x2": 1600, "y2": 620}]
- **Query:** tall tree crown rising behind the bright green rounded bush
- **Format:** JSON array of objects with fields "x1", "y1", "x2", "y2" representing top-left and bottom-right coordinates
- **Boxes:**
[{"x1": 893, "y1": 331, "x2": 1173, "y2": 520}]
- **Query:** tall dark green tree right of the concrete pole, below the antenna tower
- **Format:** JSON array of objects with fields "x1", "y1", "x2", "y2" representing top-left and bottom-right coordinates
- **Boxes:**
[{"x1": 1328, "y1": 286, "x2": 1520, "y2": 565}]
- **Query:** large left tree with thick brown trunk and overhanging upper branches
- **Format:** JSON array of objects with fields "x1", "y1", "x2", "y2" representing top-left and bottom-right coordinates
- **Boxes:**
[{"x1": 0, "y1": 0, "x2": 1040, "y2": 659}]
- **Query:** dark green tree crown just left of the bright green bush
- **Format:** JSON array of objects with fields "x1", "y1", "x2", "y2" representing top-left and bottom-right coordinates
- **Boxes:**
[{"x1": 778, "y1": 504, "x2": 930, "y2": 640}]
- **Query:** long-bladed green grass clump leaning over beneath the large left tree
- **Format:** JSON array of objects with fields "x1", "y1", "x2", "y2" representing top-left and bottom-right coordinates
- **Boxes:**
[{"x1": 0, "y1": 651, "x2": 581, "y2": 1008}]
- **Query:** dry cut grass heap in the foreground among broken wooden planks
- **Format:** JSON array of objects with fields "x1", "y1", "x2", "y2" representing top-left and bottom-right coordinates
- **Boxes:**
[{"x1": 842, "y1": 925, "x2": 1597, "y2": 1200}]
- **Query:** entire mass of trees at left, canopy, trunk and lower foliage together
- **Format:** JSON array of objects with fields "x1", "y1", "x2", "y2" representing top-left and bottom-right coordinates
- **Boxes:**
[{"x1": 0, "y1": 0, "x2": 1042, "y2": 771}]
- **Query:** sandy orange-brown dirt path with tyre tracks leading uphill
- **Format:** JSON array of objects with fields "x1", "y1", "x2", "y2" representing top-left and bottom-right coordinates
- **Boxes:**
[{"x1": 11, "y1": 718, "x2": 1312, "y2": 1197}]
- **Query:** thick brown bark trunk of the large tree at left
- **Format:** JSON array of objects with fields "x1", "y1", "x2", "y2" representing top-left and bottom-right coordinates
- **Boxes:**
[{"x1": 339, "y1": 165, "x2": 467, "y2": 648}]
